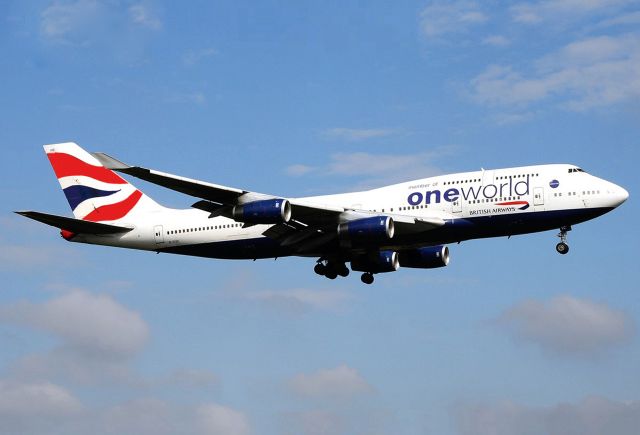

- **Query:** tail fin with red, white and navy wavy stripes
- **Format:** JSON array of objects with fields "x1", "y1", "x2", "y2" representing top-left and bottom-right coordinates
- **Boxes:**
[{"x1": 44, "y1": 142, "x2": 162, "y2": 222}]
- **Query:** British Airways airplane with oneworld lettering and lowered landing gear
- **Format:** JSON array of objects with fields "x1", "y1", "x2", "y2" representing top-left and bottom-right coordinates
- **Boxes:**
[{"x1": 16, "y1": 142, "x2": 629, "y2": 284}]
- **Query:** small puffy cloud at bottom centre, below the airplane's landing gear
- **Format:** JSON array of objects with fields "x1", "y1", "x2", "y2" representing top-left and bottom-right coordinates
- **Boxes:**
[{"x1": 289, "y1": 364, "x2": 373, "y2": 398}]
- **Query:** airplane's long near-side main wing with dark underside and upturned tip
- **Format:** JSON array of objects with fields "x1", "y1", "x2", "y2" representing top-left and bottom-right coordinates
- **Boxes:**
[{"x1": 93, "y1": 153, "x2": 445, "y2": 249}]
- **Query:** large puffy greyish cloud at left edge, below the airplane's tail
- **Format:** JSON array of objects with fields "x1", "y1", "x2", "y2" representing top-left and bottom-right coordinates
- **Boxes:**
[{"x1": 0, "y1": 290, "x2": 149, "y2": 384}]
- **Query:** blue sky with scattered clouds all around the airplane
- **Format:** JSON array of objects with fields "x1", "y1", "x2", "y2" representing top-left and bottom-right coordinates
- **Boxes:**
[{"x1": 0, "y1": 0, "x2": 640, "y2": 435}]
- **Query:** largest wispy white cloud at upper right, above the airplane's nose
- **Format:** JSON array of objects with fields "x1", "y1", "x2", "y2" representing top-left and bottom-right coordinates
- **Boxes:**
[{"x1": 471, "y1": 35, "x2": 640, "y2": 111}]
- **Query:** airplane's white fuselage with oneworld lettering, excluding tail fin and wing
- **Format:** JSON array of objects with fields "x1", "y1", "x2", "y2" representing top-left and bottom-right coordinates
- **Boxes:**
[{"x1": 73, "y1": 164, "x2": 628, "y2": 258}]
